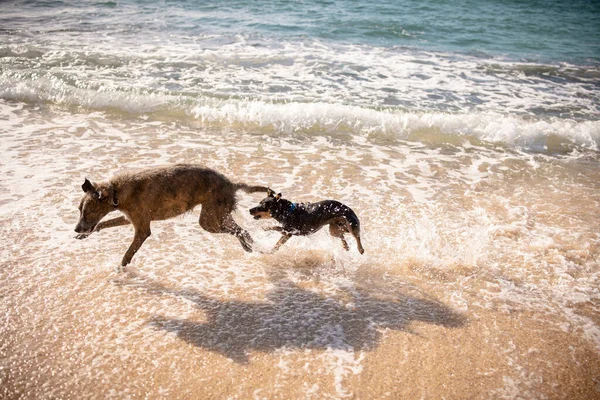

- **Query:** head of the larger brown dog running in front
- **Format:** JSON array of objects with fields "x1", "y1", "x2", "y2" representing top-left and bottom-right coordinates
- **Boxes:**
[{"x1": 75, "y1": 179, "x2": 119, "y2": 233}]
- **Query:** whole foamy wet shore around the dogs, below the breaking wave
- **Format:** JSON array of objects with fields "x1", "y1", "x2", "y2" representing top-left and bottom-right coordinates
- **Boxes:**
[{"x1": 0, "y1": 102, "x2": 600, "y2": 398}]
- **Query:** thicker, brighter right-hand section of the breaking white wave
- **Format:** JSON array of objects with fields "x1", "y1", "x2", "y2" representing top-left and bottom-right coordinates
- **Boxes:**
[{"x1": 191, "y1": 101, "x2": 600, "y2": 152}]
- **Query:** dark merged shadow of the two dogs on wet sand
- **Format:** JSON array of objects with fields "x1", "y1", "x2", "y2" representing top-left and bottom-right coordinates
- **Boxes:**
[{"x1": 118, "y1": 264, "x2": 466, "y2": 364}]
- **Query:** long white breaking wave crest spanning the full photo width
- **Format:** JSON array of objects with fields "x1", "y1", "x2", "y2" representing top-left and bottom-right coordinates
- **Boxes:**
[{"x1": 0, "y1": 71, "x2": 600, "y2": 153}]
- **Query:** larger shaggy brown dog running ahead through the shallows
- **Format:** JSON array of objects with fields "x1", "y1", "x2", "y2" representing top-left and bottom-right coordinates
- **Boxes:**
[{"x1": 75, "y1": 164, "x2": 267, "y2": 266}]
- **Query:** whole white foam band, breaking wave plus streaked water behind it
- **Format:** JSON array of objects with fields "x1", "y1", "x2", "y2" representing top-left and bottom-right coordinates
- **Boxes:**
[{"x1": 0, "y1": 35, "x2": 600, "y2": 151}]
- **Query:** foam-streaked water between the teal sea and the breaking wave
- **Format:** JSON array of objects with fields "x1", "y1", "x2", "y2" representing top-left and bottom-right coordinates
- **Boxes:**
[{"x1": 0, "y1": 35, "x2": 600, "y2": 121}]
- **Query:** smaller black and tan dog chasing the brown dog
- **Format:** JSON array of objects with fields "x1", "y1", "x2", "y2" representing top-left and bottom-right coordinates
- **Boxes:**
[{"x1": 250, "y1": 189, "x2": 365, "y2": 254}]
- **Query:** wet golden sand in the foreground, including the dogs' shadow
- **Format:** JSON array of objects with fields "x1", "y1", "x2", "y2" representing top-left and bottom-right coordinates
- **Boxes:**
[{"x1": 0, "y1": 251, "x2": 600, "y2": 399}]
